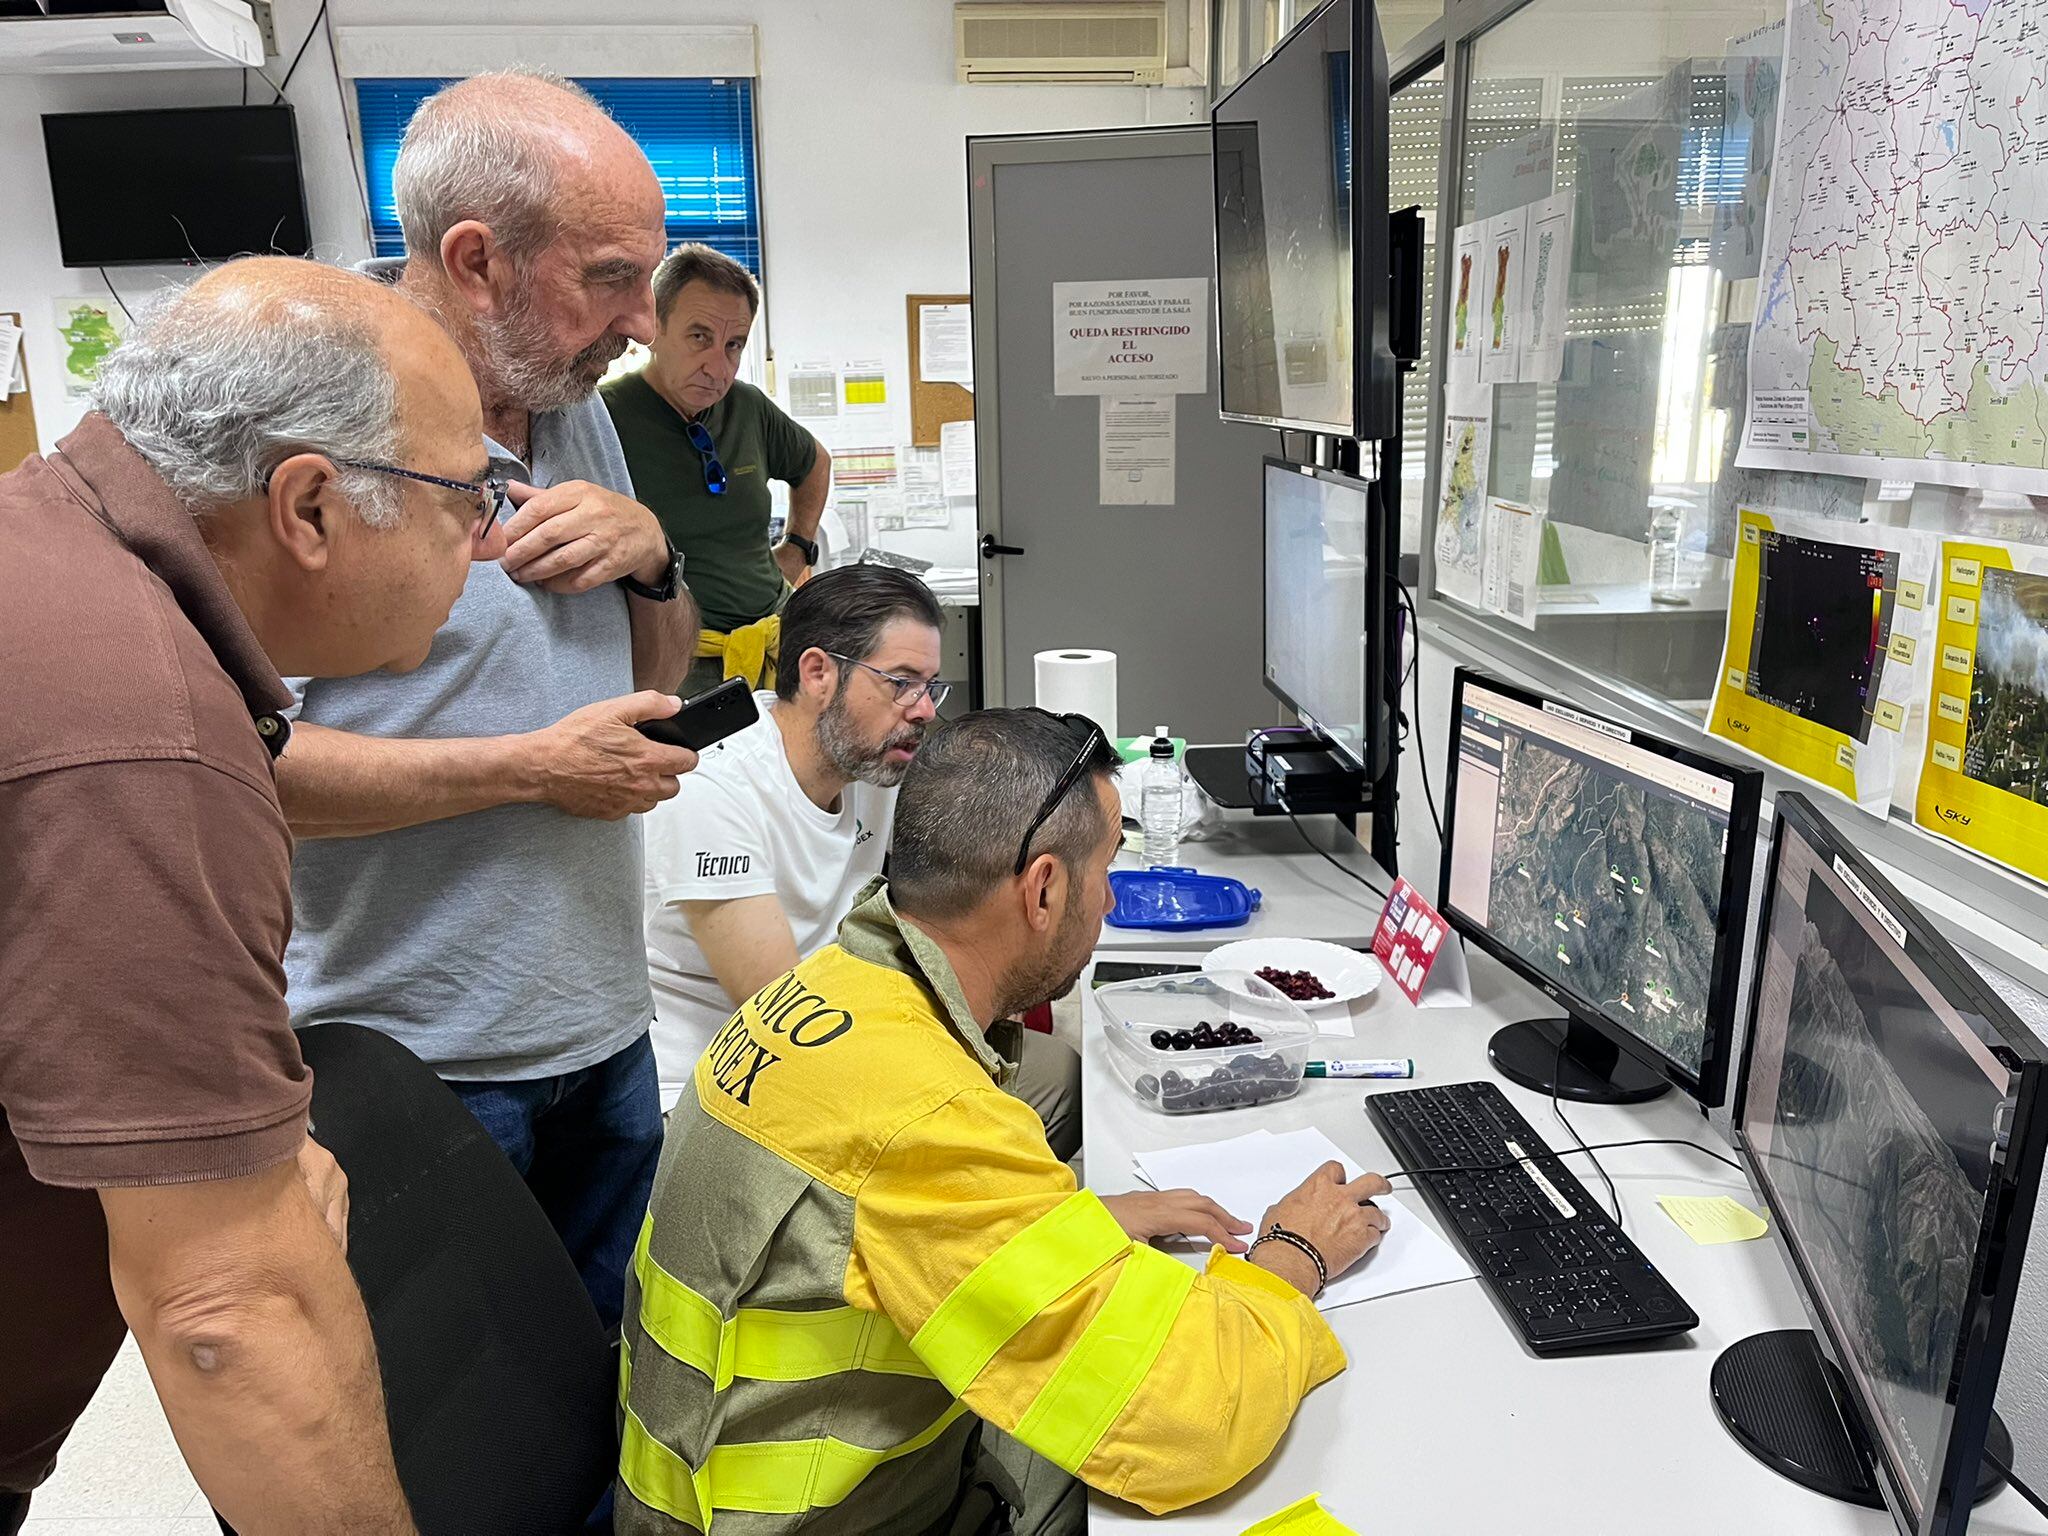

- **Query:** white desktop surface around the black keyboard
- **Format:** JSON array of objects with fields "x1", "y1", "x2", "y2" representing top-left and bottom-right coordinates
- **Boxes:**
[{"x1": 1081, "y1": 946, "x2": 2042, "y2": 1536}]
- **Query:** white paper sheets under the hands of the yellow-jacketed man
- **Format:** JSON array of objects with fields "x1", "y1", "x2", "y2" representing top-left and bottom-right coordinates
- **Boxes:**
[{"x1": 1135, "y1": 1128, "x2": 1475, "y2": 1313}]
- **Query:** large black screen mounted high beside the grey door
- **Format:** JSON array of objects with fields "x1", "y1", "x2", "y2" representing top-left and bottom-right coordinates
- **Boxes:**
[{"x1": 1210, "y1": 0, "x2": 1397, "y2": 438}]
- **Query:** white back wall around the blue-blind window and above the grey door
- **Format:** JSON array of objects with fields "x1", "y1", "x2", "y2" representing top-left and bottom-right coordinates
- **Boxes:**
[{"x1": 0, "y1": 0, "x2": 1202, "y2": 563}]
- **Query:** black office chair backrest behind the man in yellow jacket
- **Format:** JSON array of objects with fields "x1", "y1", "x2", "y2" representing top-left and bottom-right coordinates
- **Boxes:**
[{"x1": 221, "y1": 1024, "x2": 618, "y2": 1536}]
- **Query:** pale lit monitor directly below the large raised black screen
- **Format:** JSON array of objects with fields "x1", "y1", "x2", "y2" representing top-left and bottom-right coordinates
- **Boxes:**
[{"x1": 1262, "y1": 459, "x2": 1376, "y2": 776}]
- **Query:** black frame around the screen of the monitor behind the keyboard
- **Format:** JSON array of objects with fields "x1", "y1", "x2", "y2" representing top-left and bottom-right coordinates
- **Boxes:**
[{"x1": 1438, "y1": 668, "x2": 1763, "y2": 1108}]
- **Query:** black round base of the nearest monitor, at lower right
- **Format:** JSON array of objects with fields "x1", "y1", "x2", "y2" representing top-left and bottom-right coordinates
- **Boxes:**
[{"x1": 1712, "y1": 1327, "x2": 2013, "y2": 1509}]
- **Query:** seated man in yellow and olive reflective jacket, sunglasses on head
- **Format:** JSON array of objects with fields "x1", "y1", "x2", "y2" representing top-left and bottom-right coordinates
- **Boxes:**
[{"x1": 616, "y1": 711, "x2": 1386, "y2": 1536}]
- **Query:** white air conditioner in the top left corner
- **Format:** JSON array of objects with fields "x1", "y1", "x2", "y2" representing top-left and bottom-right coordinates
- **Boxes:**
[{"x1": 0, "y1": 0, "x2": 270, "y2": 74}]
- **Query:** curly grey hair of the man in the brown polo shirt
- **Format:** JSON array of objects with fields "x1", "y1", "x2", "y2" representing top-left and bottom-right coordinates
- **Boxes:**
[{"x1": 92, "y1": 272, "x2": 401, "y2": 528}]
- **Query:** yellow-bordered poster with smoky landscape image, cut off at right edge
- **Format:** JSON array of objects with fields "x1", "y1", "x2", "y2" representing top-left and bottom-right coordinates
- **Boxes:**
[{"x1": 1913, "y1": 539, "x2": 2048, "y2": 881}]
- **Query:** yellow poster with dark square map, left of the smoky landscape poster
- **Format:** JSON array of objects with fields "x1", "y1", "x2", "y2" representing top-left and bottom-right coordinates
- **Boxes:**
[{"x1": 1708, "y1": 508, "x2": 1933, "y2": 815}]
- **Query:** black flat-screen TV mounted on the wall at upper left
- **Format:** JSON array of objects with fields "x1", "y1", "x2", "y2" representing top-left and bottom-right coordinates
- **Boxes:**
[{"x1": 43, "y1": 102, "x2": 313, "y2": 266}]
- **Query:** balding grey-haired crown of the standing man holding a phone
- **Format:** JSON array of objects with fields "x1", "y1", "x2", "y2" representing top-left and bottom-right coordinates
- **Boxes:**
[{"x1": 391, "y1": 70, "x2": 604, "y2": 264}]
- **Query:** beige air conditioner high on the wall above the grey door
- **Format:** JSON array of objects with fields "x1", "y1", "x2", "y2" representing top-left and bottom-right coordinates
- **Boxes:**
[{"x1": 952, "y1": 0, "x2": 1167, "y2": 86}]
